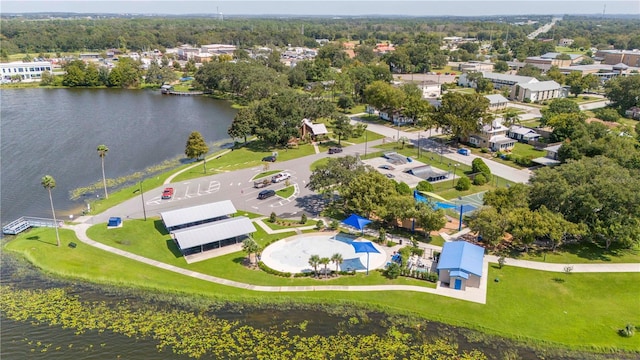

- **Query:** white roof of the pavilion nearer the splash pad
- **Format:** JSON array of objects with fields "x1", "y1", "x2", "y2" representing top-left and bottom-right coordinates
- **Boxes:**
[{"x1": 172, "y1": 216, "x2": 256, "y2": 250}]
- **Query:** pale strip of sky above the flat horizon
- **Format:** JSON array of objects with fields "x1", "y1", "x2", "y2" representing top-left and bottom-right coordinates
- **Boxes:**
[{"x1": 0, "y1": 0, "x2": 640, "y2": 19}]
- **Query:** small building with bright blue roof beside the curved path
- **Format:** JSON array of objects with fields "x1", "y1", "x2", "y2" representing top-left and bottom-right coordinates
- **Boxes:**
[{"x1": 437, "y1": 241, "x2": 484, "y2": 290}]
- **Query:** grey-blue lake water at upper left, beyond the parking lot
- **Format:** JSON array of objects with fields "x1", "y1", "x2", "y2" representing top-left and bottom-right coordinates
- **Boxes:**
[{"x1": 0, "y1": 89, "x2": 236, "y2": 224}]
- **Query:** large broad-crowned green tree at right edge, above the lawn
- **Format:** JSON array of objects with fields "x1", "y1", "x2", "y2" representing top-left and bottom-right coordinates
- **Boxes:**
[{"x1": 530, "y1": 156, "x2": 640, "y2": 249}]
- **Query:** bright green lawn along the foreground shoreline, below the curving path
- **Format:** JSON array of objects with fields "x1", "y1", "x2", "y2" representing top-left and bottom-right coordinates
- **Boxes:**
[{"x1": 5, "y1": 226, "x2": 640, "y2": 352}]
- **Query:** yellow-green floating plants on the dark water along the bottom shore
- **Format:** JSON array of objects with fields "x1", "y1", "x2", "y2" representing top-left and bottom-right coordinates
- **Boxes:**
[{"x1": 0, "y1": 286, "x2": 486, "y2": 360}]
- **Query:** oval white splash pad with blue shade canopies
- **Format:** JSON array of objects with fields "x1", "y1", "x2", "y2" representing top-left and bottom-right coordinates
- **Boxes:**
[{"x1": 261, "y1": 233, "x2": 387, "y2": 273}]
